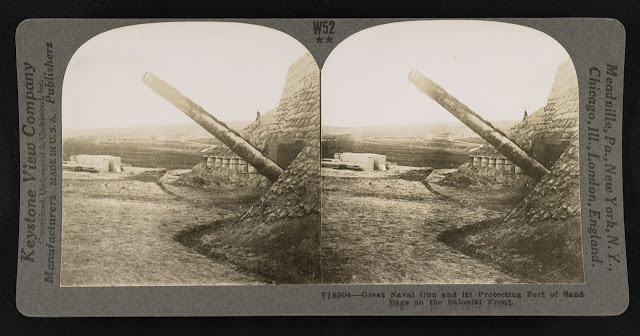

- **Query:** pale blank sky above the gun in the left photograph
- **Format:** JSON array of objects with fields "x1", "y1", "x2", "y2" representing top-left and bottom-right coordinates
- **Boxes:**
[{"x1": 62, "y1": 22, "x2": 307, "y2": 129}]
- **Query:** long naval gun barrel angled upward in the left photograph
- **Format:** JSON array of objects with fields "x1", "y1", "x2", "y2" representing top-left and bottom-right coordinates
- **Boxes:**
[{"x1": 142, "y1": 72, "x2": 283, "y2": 182}]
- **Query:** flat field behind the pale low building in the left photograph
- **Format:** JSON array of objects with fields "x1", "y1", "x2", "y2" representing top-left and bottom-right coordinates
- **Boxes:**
[{"x1": 62, "y1": 137, "x2": 207, "y2": 169}]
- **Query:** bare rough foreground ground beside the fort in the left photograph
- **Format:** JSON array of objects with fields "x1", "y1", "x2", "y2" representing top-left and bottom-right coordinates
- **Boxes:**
[{"x1": 61, "y1": 171, "x2": 262, "y2": 286}]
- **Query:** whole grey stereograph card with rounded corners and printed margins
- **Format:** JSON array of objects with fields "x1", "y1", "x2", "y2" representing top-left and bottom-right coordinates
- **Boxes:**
[{"x1": 16, "y1": 18, "x2": 629, "y2": 316}]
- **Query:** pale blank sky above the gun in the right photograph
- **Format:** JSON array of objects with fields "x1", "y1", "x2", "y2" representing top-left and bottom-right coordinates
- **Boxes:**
[{"x1": 321, "y1": 20, "x2": 569, "y2": 127}]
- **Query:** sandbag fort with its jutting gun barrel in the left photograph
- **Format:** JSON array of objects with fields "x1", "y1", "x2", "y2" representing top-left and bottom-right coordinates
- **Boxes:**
[{"x1": 143, "y1": 53, "x2": 321, "y2": 283}]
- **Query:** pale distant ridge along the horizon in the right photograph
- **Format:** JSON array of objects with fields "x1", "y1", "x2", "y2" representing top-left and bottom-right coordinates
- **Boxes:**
[{"x1": 322, "y1": 120, "x2": 520, "y2": 138}]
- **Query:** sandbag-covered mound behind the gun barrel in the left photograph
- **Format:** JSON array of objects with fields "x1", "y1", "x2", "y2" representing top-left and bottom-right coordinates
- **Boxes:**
[{"x1": 183, "y1": 53, "x2": 321, "y2": 283}]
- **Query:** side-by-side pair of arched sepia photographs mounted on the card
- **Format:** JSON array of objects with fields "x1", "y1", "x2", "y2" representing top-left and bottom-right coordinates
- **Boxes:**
[{"x1": 61, "y1": 21, "x2": 584, "y2": 287}]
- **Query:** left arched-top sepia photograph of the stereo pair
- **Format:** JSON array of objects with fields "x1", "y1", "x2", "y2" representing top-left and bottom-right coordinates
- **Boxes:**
[{"x1": 60, "y1": 22, "x2": 322, "y2": 287}]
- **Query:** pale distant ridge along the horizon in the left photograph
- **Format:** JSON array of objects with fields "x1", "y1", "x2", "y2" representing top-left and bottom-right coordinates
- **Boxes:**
[{"x1": 62, "y1": 121, "x2": 253, "y2": 139}]
